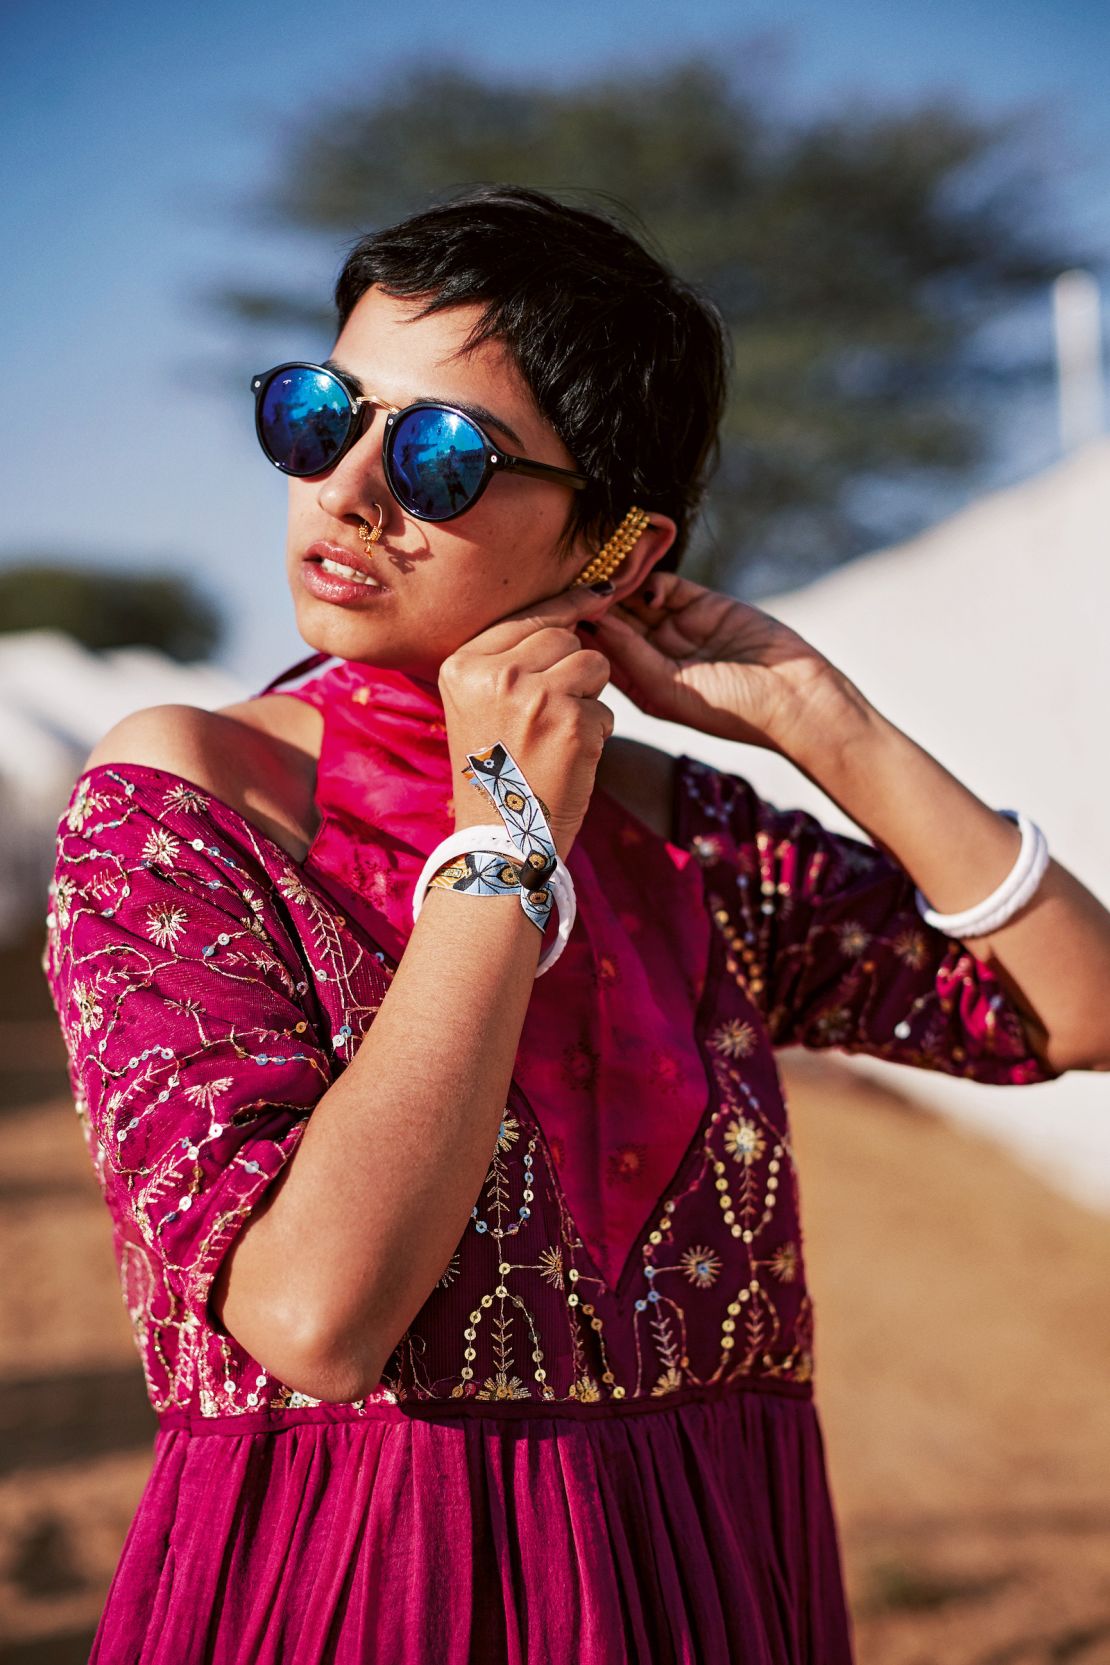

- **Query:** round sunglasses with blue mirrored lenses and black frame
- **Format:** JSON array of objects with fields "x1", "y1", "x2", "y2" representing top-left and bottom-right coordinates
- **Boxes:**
[{"x1": 251, "y1": 361, "x2": 591, "y2": 521}]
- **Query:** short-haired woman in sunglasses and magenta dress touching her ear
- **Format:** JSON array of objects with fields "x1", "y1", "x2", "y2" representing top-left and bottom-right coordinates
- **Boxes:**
[{"x1": 45, "y1": 188, "x2": 1110, "y2": 1665}]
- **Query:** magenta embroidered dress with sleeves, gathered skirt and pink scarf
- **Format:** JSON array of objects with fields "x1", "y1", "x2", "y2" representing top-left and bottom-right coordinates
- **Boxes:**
[{"x1": 43, "y1": 656, "x2": 1053, "y2": 1665}]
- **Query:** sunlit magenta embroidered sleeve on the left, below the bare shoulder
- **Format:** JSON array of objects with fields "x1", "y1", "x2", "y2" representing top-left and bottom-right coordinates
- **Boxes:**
[{"x1": 42, "y1": 766, "x2": 333, "y2": 1334}]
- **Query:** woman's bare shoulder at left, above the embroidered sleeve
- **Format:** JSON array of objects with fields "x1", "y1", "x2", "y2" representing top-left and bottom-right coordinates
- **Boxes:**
[{"x1": 82, "y1": 696, "x2": 323, "y2": 861}]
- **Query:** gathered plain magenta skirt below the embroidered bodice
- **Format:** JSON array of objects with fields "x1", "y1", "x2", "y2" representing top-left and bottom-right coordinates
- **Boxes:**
[{"x1": 90, "y1": 1384, "x2": 852, "y2": 1665}]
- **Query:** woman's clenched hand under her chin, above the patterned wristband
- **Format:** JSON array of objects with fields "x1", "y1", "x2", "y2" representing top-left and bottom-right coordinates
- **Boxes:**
[{"x1": 439, "y1": 586, "x2": 614, "y2": 861}]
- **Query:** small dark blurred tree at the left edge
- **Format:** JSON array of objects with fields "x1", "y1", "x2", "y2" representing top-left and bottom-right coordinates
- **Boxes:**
[{"x1": 0, "y1": 558, "x2": 223, "y2": 663}]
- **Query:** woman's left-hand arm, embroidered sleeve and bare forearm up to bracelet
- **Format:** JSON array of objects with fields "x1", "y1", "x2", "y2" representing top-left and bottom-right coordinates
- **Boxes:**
[{"x1": 43, "y1": 742, "x2": 552, "y2": 1414}]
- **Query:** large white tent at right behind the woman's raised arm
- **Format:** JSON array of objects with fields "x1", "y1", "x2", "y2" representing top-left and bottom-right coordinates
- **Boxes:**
[{"x1": 602, "y1": 440, "x2": 1110, "y2": 1209}]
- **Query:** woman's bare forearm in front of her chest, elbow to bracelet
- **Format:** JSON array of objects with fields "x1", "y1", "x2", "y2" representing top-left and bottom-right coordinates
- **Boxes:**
[{"x1": 216, "y1": 887, "x2": 541, "y2": 1400}]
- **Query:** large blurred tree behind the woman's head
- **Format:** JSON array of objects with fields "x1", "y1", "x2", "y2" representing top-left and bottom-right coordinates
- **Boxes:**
[{"x1": 211, "y1": 55, "x2": 1102, "y2": 589}]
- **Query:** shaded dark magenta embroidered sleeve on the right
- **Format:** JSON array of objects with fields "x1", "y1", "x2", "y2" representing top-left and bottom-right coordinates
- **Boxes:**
[{"x1": 682, "y1": 758, "x2": 1062, "y2": 1086}]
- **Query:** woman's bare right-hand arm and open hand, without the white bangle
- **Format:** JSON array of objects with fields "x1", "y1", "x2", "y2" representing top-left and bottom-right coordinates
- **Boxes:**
[{"x1": 597, "y1": 573, "x2": 1110, "y2": 1071}]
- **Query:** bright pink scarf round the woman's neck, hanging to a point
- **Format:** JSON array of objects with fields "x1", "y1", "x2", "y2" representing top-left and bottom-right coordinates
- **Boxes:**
[{"x1": 266, "y1": 656, "x2": 711, "y2": 1287}]
